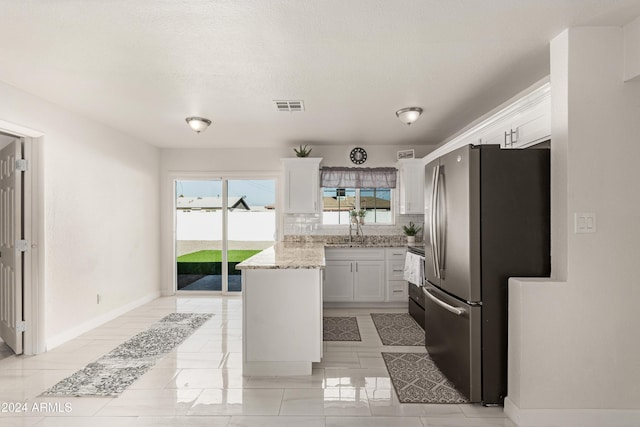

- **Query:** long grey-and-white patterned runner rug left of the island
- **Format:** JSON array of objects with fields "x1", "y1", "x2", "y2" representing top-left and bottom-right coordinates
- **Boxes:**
[{"x1": 42, "y1": 313, "x2": 213, "y2": 397}]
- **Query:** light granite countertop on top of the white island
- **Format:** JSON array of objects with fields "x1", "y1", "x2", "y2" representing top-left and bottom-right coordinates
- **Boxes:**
[{"x1": 236, "y1": 242, "x2": 326, "y2": 270}]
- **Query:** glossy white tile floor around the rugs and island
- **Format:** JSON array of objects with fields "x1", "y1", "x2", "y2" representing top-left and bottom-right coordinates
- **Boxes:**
[{"x1": 0, "y1": 296, "x2": 514, "y2": 427}]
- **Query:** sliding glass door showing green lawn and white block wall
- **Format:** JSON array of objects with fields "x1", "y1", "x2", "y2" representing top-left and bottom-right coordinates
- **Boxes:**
[{"x1": 175, "y1": 178, "x2": 276, "y2": 293}]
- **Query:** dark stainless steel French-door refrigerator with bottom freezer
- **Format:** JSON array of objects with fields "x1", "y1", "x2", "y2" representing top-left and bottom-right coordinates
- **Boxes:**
[{"x1": 423, "y1": 145, "x2": 551, "y2": 405}]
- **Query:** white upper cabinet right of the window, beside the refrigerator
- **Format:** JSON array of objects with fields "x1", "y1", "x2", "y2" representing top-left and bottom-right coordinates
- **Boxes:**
[{"x1": 398, "y1": 159, "x2": 424, "y2": 214}]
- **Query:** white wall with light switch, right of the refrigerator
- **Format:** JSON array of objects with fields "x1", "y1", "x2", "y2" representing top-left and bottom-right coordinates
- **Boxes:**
[{"x1": 505, "y1": 27, "x2": 640, "y2": 426}]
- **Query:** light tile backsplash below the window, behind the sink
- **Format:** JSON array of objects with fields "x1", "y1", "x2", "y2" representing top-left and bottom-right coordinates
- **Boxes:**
[{"x1": 284, "y1": 214, "x2": 424, "y2": 241}]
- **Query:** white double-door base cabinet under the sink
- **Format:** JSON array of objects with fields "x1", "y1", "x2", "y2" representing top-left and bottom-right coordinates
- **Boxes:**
[{"x1": 323, "y1": 248, "x2": 385, "y2": 302}]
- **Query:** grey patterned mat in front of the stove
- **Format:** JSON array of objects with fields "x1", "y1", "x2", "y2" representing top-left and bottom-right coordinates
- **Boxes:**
[{"x1": 371, "y1": 313, "x2": 424, "y2": 346}]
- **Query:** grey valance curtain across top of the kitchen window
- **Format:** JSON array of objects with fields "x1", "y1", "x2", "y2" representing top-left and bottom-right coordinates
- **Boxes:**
[{"x1": 320, "y1": 167, "x2": 397, "y2": 188}]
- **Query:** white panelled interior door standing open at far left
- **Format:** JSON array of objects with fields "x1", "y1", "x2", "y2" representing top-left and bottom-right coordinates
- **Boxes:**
[{"x1": 0, "y1": 140, "x2": 23, "y2": 354}]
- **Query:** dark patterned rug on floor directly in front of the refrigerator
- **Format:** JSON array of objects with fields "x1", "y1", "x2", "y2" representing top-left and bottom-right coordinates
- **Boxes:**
[{"x1": 382, "y1": 353, "x2": 468, "y2": 403}]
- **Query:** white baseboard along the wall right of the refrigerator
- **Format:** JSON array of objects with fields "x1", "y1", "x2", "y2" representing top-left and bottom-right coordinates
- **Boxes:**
[{"x1": 504, "y1": 397, "x2": 640, "y2": 427}]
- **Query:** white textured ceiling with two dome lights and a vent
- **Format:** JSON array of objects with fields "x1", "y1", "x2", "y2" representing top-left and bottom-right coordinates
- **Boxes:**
[{"x1": 0, "y1": 0, "x2": 640, "y2": 148}]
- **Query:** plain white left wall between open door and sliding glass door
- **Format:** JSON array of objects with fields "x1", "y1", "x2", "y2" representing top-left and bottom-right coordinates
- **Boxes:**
[{"x1": 0, "y1": 83, "x2": 160, "y2": 352}]
